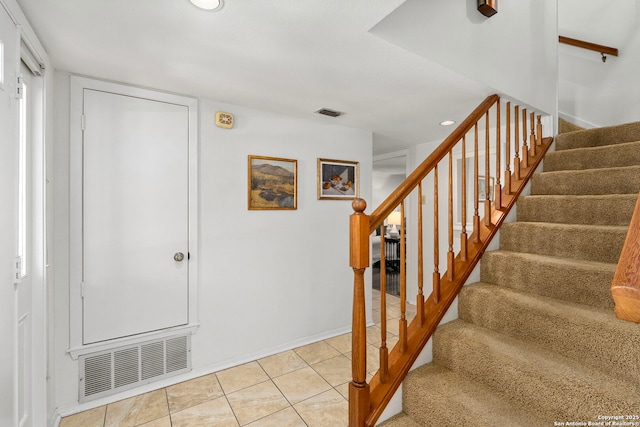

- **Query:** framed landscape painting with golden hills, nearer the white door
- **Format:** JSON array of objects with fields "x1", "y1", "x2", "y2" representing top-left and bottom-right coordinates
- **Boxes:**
[{"x1": 247, "y1": 155, "x2": 298, "y2": 210}]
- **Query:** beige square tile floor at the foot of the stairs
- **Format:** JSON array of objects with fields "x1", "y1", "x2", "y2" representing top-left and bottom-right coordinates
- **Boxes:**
[{"x1": 60, "y1": 290, "x2": 415, "y2": 427}]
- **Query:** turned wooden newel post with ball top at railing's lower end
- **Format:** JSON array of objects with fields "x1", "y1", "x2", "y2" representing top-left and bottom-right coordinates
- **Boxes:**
[{"x1": 349, "y1": 199, "x2": 370, "y2": 427}]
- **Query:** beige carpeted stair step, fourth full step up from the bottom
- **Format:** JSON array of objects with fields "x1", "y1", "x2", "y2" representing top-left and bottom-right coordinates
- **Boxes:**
[{"x1": 480, "y1": 250, "x2": 616, "y2": 312}]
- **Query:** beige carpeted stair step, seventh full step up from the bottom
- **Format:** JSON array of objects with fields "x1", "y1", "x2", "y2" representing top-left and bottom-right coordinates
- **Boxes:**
[{"x1": 531, "y1": 166, "x2": 640, "y2": 195}]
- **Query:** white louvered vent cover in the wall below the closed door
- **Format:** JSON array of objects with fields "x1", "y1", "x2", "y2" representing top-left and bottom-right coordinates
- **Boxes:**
[{"x1": 79, "y1": 335, "x2": 191, "y2": 403}]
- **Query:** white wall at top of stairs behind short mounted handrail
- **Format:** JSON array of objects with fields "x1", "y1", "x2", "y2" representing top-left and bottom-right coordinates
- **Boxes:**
[{"x1": 558, "y1": 0, "x2": 640, "y2": 127}]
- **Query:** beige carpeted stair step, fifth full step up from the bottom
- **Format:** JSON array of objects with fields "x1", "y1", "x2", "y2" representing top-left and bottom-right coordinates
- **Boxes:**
[{"x1": 500, "y1": 221, "x2": 628, "y2": 263}]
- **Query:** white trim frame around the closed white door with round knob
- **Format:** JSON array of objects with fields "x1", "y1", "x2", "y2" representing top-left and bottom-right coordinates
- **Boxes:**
[{"x1": 67, "y1": 75, "x2": 198, "y2": 360}]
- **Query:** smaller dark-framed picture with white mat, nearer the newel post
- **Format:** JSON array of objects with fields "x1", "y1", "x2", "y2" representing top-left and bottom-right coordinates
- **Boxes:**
[{"x1": 318, "y1": 159, "x2": 360, "y2": 200}]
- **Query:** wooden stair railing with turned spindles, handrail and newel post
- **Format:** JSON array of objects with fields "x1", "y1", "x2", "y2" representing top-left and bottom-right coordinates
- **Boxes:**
[{"x1": 349, "y1": 95, "x2": 552, "y2": 427}]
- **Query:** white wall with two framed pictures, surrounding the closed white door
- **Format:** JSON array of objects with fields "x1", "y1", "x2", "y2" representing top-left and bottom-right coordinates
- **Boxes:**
[{"x1": 55, "y1": 72, "x2": 372, "y2": 412}]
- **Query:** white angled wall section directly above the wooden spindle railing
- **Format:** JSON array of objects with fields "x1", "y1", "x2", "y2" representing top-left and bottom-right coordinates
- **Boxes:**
[{"x1": 371, "y1": 0, "x2": 558, "y2": 116}]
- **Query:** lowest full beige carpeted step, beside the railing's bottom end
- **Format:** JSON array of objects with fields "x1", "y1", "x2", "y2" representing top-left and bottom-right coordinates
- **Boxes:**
[{"x1": 403, "y1": 363, "x2": 544, "y2": 427}]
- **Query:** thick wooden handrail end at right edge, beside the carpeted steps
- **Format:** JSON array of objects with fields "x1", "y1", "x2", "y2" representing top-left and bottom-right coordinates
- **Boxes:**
[{"x1": 611, "y1": 192, "x2": 640, "y2": 323}]
